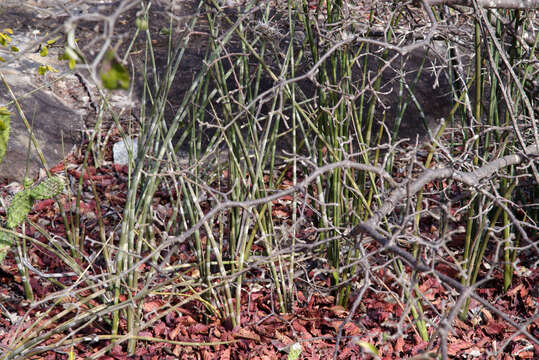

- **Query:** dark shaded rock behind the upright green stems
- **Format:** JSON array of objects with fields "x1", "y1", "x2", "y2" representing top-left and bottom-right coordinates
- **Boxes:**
[{"x1": 127, "y1": 1, "x2": 453, "y2": 155}]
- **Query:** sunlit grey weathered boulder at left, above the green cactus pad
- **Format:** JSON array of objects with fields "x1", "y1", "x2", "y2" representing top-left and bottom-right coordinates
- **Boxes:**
[{"x1": 0, "y1": 3, "x2": 91, "y2": 181}]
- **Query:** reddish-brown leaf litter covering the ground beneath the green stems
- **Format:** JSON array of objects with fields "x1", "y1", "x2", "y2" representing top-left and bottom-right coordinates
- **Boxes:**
[{"x1": 0, "y1": 131, "x2": 539, "y2": 360}]
